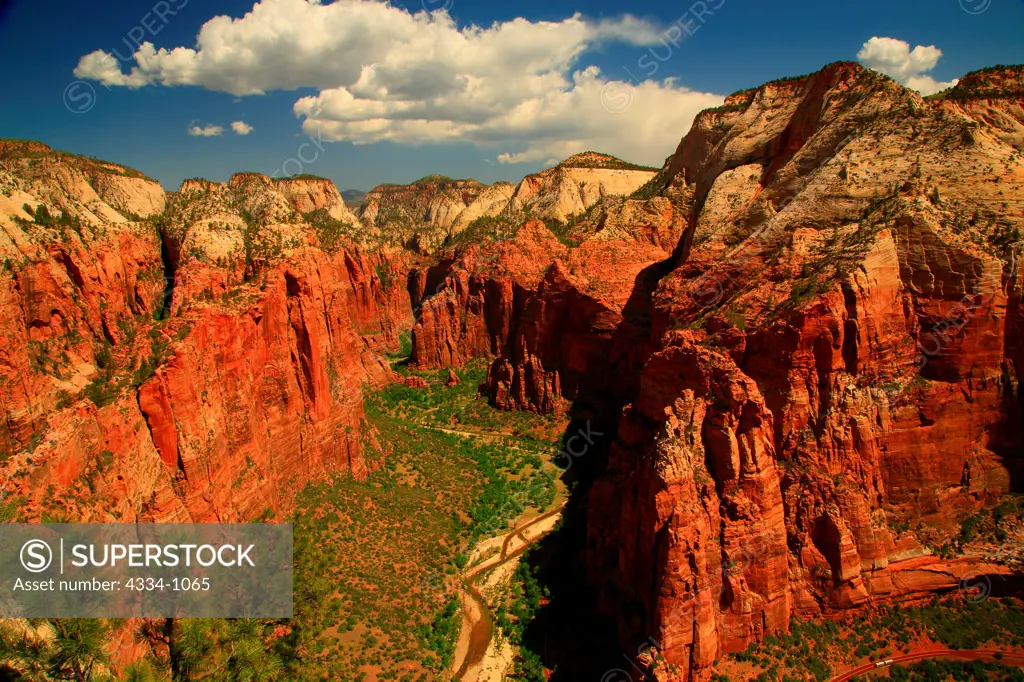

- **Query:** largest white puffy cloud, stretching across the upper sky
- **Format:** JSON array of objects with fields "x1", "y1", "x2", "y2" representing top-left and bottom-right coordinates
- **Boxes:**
[{"x1": 75, "y1": 0, "x2": 723, "y2": 164}]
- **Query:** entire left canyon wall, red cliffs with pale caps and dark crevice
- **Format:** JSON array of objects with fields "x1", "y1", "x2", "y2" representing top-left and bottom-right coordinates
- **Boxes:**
[{"x1": 0, "y1": 160, "x2": 412, "y2": 521}]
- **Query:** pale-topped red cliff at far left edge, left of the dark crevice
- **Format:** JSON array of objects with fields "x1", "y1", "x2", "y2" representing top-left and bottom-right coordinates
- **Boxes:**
[{"x1": 0, "y1": 142, "x2": 164, "y2": 462}]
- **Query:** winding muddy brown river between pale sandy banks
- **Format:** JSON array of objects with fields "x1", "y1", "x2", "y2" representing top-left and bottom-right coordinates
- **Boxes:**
[{"x1": 452, "y1": 504, "x2": 564, "y2": 682}]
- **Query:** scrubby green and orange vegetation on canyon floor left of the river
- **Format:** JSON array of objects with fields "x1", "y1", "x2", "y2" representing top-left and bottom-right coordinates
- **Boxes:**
[{"x1": 268, "y1": 358, "x2": 556, "y2": 681}]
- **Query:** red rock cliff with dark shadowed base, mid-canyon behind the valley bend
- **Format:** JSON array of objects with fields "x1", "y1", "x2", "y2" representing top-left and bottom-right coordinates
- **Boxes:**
[{"x1": 412, "y1": 198, "x2": 685, "y2": 413}]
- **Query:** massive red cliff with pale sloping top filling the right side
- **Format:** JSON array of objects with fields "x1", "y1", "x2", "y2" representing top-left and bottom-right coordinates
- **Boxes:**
[{"x1": 588, "y1": 65, "x2": 1024, "y2": 679}]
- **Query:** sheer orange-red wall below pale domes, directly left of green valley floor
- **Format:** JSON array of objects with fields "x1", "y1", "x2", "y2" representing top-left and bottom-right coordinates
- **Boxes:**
[{"x1": 138, "y1": 252, "x2": 389, "y2": 520}]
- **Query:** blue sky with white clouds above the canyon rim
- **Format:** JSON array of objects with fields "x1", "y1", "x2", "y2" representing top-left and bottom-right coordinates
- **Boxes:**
[{"x1": 0, "y1": 0, "x2": 1024, "y2": 189}]
